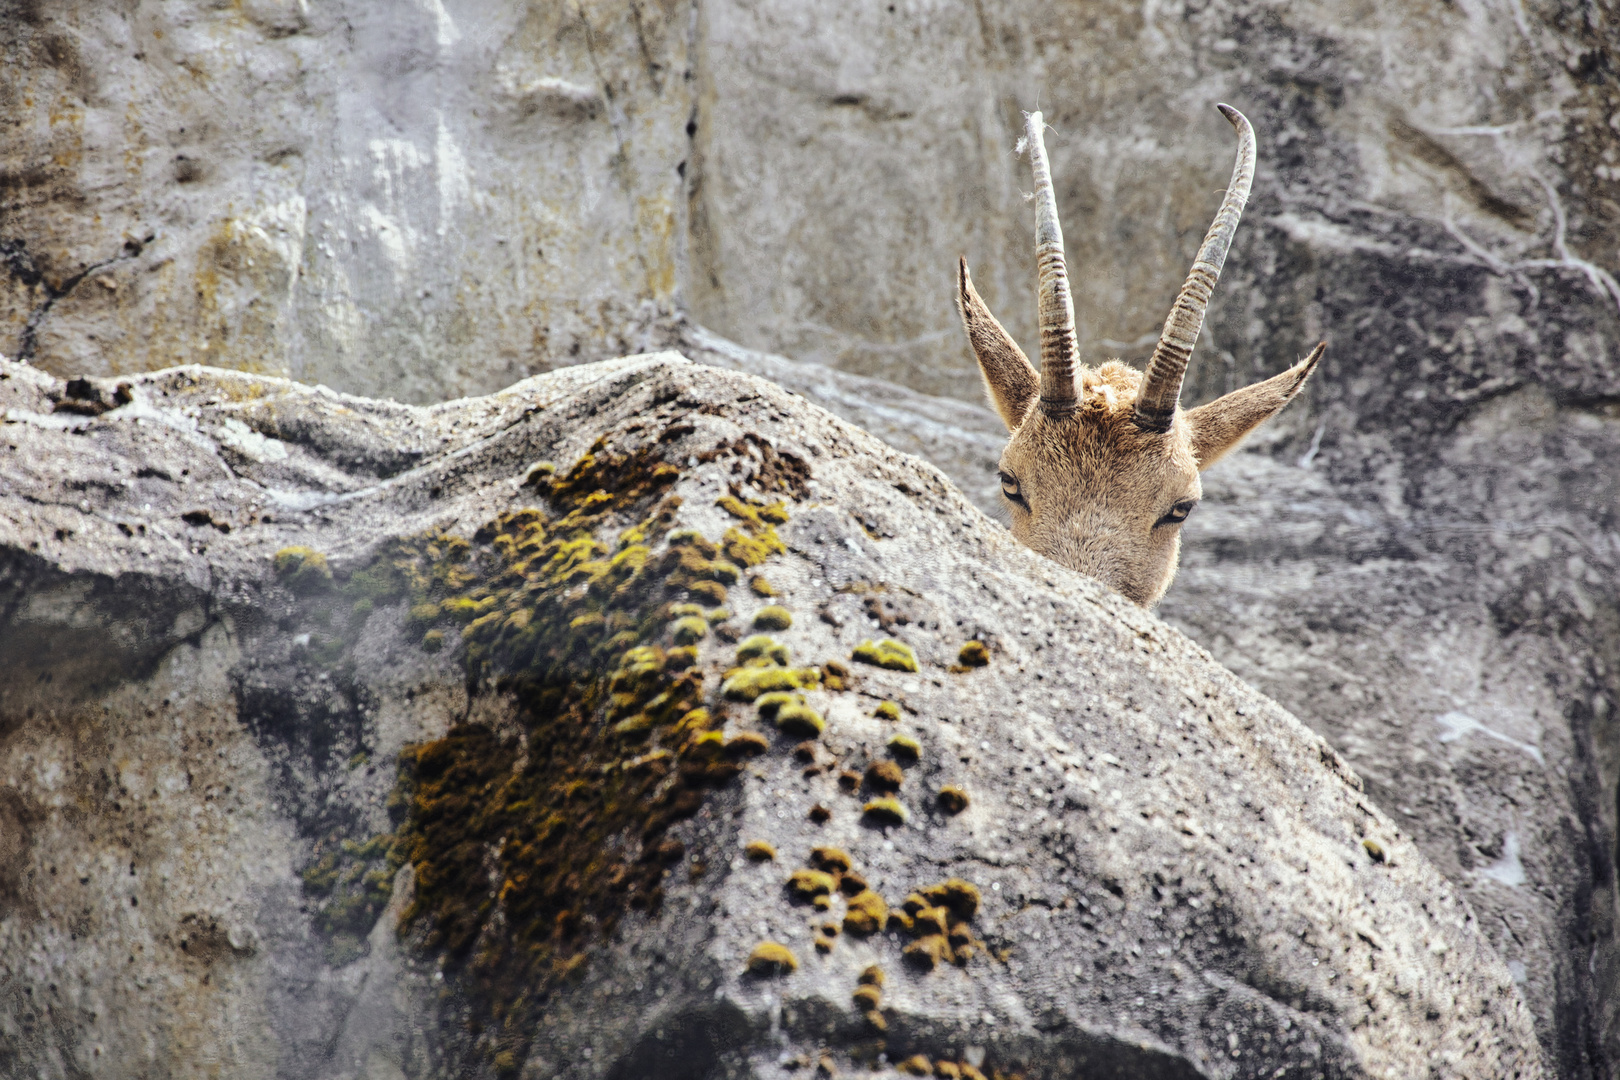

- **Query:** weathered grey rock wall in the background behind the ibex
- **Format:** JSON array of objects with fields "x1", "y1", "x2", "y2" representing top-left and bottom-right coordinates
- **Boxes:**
[{"x1": 0, "y1": 0, "x2": 1620, "y2": 1077}]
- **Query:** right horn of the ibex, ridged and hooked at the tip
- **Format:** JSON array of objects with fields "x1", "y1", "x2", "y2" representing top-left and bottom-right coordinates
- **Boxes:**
[{"x1": 1136, "y1": 105, "x2": 1254, "y2": 432}]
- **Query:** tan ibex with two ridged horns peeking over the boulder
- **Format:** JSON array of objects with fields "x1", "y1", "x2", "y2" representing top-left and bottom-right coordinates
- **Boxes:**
[{"x1": 957, "y1": 105, "x2": 1327, "y2": 607}]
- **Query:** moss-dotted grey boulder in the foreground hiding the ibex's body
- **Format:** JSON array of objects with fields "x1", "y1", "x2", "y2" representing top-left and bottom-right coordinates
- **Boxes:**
[{"x1": 0, "y1": 355, "x2": 1544, "y2": 1078}]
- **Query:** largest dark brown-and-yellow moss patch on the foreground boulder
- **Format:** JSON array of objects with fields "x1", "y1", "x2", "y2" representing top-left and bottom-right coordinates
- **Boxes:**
[{"x1": 367, "y1": 430, "x2": 803, "y2": 1061}]
